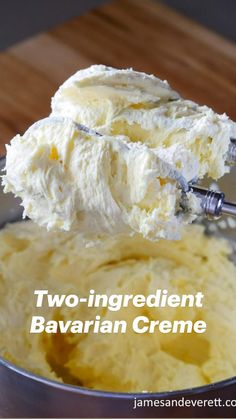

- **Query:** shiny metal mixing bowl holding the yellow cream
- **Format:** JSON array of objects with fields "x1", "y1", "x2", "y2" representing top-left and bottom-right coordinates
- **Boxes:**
[{"x1": 0, "y1": 157, "x2": 236, "y2": 418}]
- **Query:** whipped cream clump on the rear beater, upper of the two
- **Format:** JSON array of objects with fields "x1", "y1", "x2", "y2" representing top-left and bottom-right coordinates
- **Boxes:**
[{"x1": 52, "y1": 65, "x2": 236, "y2": 180}]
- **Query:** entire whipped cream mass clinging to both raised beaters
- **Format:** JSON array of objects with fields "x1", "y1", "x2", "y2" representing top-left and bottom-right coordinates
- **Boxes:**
[{"x1": 3, "y1": 65, "x2": 236, "y2": 242}]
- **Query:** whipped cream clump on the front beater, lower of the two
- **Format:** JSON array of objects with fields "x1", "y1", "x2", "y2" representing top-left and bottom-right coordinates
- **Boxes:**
[{"x1": 3, "y1": 118, "x2": 197, "y2": 242}]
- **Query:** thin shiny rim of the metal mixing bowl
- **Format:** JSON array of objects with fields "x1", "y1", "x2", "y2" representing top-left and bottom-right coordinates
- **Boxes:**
[{"x1": 0, "y1": 155, "x2": 236, "y2": 400}]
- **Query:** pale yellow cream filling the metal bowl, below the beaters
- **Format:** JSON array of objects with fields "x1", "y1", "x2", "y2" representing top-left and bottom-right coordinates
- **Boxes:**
[{"x1": 0, "y1": 221, "x2": 236, "y2": 392}]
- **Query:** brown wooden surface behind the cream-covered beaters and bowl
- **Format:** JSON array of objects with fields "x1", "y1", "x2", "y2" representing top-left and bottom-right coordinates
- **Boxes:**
[{"x1": 0, "y1": 0, "x2": 236, "y2": 153}]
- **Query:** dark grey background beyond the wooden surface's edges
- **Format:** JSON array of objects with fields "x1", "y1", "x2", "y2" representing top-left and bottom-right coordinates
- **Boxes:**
[{"x1": 0, "y1": 0, "x2": 236, "y2": 50}]
